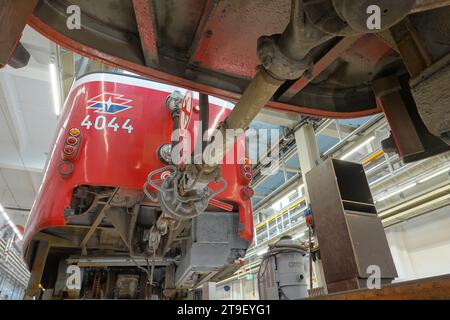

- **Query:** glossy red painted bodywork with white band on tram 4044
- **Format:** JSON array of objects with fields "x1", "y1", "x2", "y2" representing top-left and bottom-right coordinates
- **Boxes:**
[{"x1": 24, "y1": 74, "x2": 253, "y2": 250}]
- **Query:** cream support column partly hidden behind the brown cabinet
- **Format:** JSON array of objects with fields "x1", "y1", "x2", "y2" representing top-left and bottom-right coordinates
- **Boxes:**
[{"x1": 294, "y1": 123, "x2": 327, "y2": 292}]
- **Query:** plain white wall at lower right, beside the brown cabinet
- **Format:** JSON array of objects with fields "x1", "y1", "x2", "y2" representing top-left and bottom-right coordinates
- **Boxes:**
[{"x1": 386, "y1": 207, "x2": 450, "y2": 281}]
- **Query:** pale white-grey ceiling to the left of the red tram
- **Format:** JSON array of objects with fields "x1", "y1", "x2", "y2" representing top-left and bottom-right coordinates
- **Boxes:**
[{"x1": 0, "y1": 27, "x2": 57, "y2": 225}]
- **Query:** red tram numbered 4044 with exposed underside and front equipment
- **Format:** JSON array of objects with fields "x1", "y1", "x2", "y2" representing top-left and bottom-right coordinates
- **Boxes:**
[{"x1": 24, "y1": 73, "x2": 253, "y2": 299}]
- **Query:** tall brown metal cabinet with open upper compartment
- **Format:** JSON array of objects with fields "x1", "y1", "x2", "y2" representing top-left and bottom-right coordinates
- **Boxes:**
[{"x1": 306, "y1": 159, "x2": 397, "y2": 293}]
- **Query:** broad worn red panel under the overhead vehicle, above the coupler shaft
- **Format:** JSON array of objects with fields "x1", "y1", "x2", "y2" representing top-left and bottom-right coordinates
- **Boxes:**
[{"x1": 192, "y1": 0, "x2": 290, "y2": 79}]
